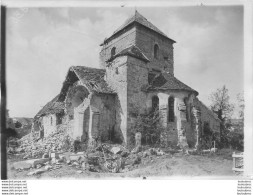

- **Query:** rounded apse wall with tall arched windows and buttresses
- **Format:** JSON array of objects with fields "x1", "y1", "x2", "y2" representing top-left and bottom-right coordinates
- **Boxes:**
[{"x1": 147, "y1": 90, "x2": 197, "y2": 147}]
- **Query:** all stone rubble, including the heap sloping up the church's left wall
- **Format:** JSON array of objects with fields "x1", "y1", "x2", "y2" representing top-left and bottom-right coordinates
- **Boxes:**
[{"x1": 9, "y1": 132, "x2": 174, "y2": 175}]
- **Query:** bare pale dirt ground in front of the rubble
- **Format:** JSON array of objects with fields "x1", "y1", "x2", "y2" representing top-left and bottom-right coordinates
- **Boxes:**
[{"x1": 8, "y1": 150, "x2": 240, "y2": 179}]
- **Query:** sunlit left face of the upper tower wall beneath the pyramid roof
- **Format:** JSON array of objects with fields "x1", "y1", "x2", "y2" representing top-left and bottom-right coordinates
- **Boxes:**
[{"x1": 99, "y1": 26, "x2": 136, "y2": 68}]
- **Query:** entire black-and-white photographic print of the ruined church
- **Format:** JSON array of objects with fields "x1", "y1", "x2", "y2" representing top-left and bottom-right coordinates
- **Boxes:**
[{"x1": 1, "y1": 2, "x2": 252, "y2": 183}]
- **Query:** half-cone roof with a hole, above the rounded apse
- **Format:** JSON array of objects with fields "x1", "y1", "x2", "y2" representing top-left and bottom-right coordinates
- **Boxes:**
[{"x1": 146, "y1": 72, "x2": 198, "y2": 95}]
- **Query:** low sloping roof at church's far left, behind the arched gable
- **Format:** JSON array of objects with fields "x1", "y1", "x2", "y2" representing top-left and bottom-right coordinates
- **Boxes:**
[{"x1": 34, "y1": 95, "x2": 64, "y2": 120}]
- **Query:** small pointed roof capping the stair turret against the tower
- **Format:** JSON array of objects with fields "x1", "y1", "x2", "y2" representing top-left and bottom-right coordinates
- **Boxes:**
[{"x1": 107, "y1": 45, "x2": 150, "y2": 62}]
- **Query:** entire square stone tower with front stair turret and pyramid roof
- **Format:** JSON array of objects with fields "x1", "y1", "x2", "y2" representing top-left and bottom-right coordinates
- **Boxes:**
[{"x1": 100, "y1": 11, "x2": 175, "y2": 144}]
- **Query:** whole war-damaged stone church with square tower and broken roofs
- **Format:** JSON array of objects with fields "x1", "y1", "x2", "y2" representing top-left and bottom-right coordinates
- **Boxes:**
[{"x1": 33, "y1": 11, "x2": 220, "y2": 148}]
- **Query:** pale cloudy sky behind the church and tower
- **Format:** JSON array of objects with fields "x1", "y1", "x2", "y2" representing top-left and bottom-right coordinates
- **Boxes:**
[{"x1": 6, "y1": 6, "x2": 244, "y2": 117}]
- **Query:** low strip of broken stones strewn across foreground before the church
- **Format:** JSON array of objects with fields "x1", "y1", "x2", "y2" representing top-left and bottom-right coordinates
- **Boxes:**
[{"x1": 10, "y1": 144, "x2": 170, "y2": 176}]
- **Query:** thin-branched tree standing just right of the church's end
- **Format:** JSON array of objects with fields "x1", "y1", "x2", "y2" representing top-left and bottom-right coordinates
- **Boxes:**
[{"x1": 209, "y1": 85, "x2": 234, "y2": 144}]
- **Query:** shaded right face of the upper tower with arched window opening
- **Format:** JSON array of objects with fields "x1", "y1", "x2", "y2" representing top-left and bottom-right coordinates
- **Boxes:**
[{"x1": 136, "y1": 25, "x2": 174, "y2": 74}]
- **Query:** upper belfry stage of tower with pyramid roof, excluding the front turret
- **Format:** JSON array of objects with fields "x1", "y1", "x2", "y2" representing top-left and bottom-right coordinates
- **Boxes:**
[{"x1": 100, "y1": 11, "x2": 175, "y2": 75}]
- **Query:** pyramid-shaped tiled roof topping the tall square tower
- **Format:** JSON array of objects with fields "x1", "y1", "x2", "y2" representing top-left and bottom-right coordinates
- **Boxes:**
[{"x1": 101, "y1": 10, "x2": 176, "y2": 45}]
